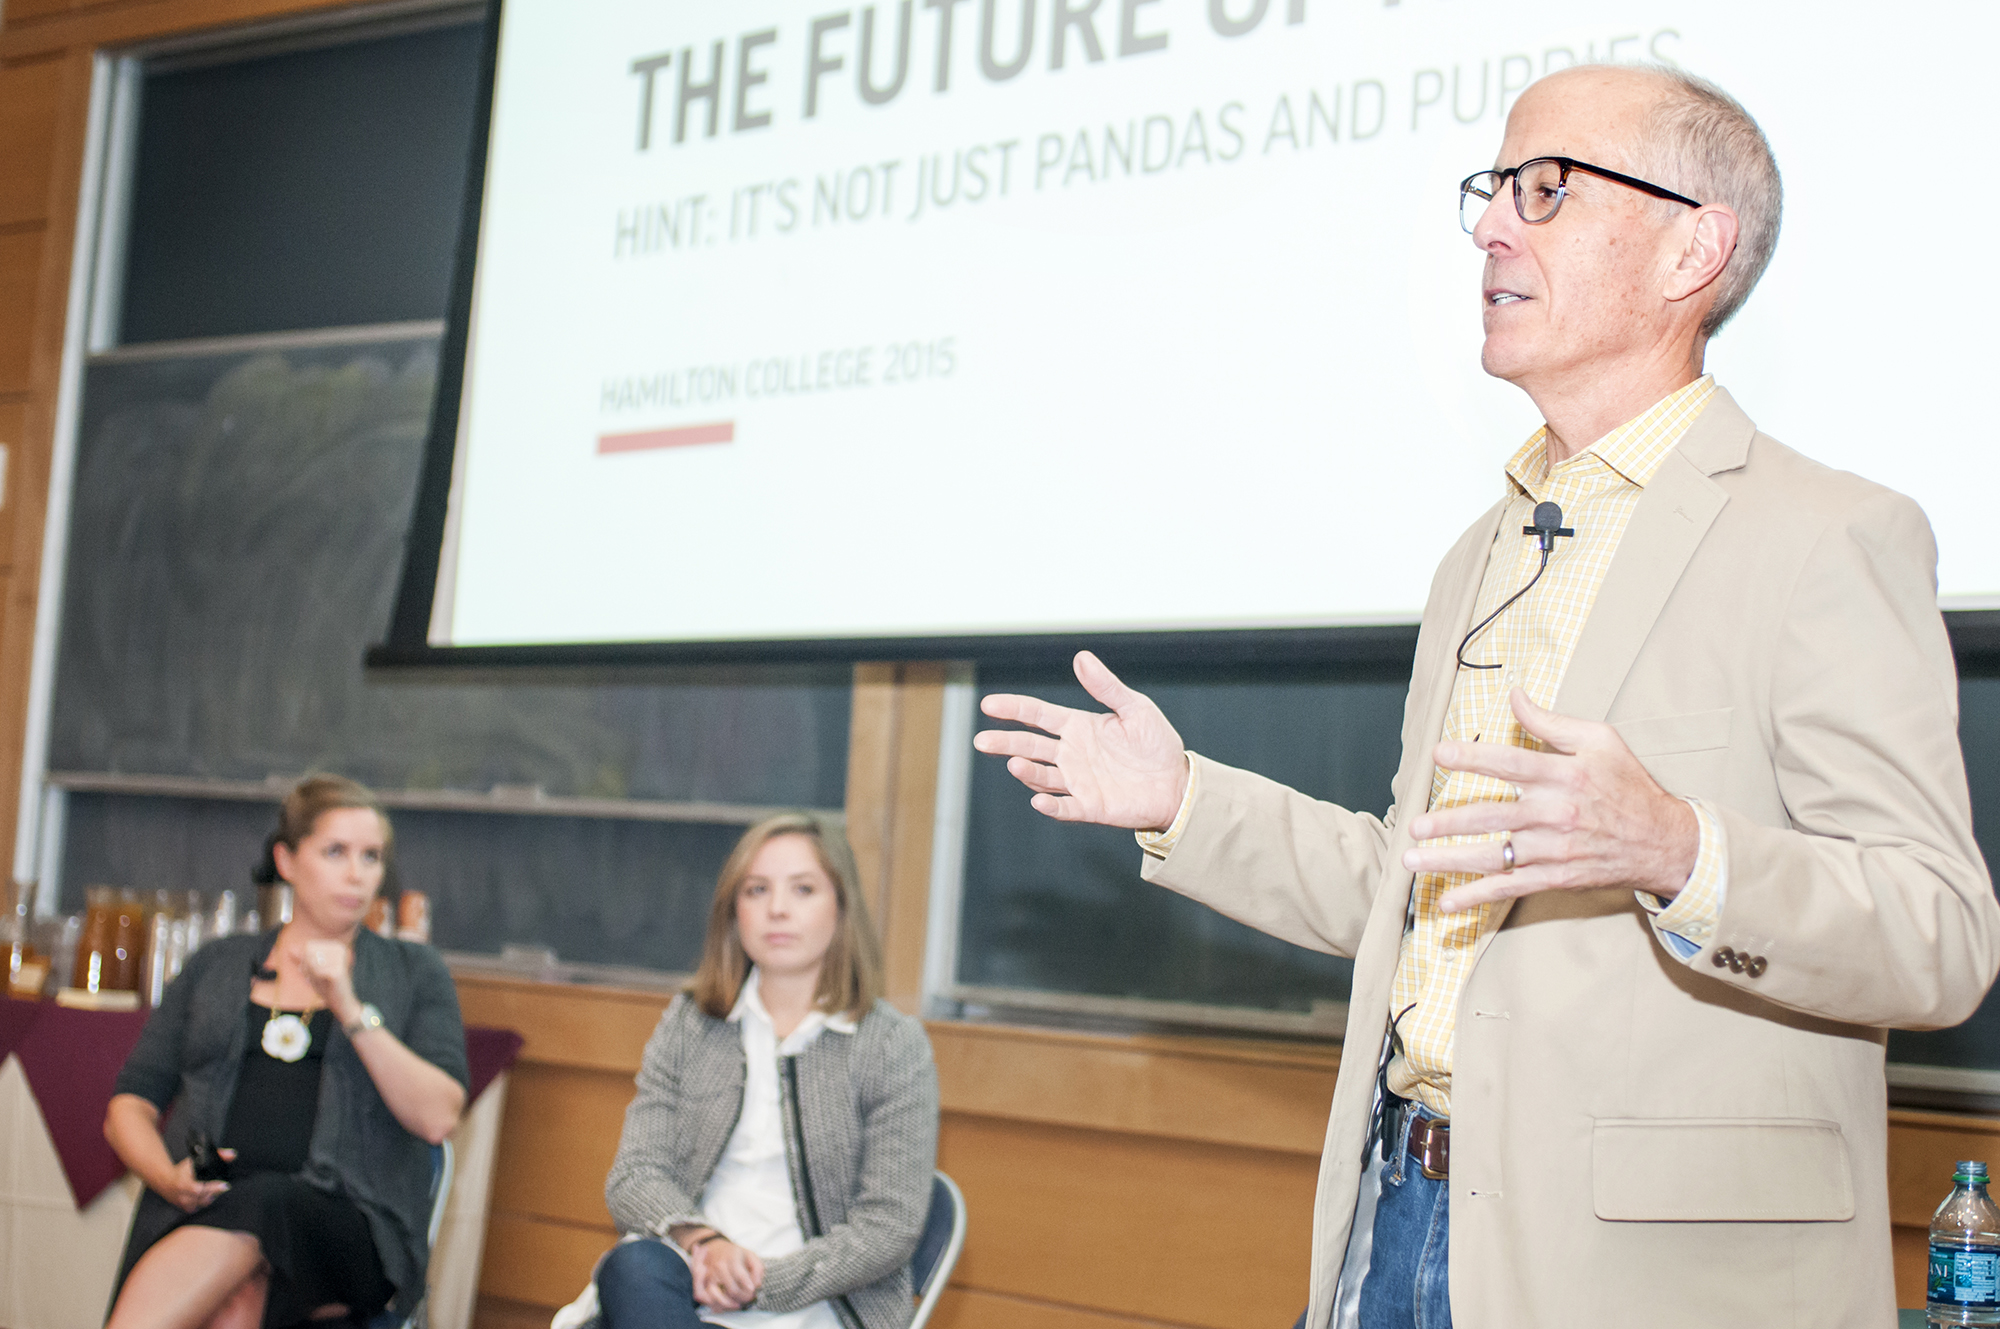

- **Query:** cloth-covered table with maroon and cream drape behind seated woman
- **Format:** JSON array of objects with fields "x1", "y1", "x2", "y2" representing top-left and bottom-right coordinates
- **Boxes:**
[{"x1": 0, "y1": 999, "x2": 520, "y2": 1329}]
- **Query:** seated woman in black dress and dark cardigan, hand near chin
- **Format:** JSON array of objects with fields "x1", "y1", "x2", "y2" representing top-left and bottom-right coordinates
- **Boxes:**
[{"x1": 104, "y1": 775, "x2": 466, "y2": 1329}]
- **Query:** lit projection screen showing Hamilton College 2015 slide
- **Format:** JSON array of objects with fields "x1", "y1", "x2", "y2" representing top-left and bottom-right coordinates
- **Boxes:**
[{"x1": 406, "y1": 0, "x2": 2000, "y2": 646}]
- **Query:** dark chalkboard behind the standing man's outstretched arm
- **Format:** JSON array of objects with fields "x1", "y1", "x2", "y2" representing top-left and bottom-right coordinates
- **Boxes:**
[{"x1": 958, "y1": 662, "x2": 2000, "y2": 1072}]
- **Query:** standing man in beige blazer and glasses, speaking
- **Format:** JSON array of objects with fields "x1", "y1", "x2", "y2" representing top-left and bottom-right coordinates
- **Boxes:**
[{"x1": 976, "y1": 66, "x2": 2000, "y2": 1329}]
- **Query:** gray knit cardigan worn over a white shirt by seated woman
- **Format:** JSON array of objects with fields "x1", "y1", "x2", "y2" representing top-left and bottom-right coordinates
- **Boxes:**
[{"x1": 604, "y1": 997, "x2": 938, "y2": 1329}]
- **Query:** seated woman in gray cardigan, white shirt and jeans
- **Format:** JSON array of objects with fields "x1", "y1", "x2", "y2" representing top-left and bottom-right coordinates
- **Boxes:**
[{"x1": 584, "y1": 813, "x2": 938, "y2": 1329}]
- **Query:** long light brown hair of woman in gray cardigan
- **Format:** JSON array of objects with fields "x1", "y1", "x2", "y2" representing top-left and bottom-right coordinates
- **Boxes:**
[{"x1": 686, "y1": 813, "x2": 882, "y2": 1019}]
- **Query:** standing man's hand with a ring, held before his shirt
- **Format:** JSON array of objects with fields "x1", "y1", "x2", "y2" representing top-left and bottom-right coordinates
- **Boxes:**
[{"x1": 1402, "y1": 689, "x2": 1702, "y2": 913}]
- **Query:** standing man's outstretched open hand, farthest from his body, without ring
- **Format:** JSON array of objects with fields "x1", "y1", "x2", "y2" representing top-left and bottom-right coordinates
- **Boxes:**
[{"x1": 972, "y1": 650, "x2": 1188, "y2": 831}]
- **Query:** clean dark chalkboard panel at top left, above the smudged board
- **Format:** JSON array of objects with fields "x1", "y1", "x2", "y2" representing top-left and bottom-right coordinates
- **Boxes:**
[{"x1": 118, "y1": 16, "x2": 480, "y2": 342}]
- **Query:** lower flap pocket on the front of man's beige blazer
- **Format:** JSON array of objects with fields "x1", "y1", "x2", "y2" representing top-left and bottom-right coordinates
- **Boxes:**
[{"x1": 1590, "y1": 1117, "x2": 1854, "y2": 1223}]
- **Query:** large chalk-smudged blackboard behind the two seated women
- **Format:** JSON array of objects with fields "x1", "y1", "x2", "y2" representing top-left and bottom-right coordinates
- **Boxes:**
[{"x1": 50, "y1": 338, "x2": 850, "y2": 967}]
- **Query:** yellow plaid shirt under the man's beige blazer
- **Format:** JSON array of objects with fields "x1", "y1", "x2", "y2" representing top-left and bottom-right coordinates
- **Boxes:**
[{"x1": 1138, "y1": 376, "x2": 1726, "y2": 1117}]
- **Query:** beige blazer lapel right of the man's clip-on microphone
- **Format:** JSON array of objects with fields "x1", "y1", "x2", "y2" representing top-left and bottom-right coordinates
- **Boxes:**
[{"x1": 1556, "y1": 388, "x2": 1756, "y2": 721}]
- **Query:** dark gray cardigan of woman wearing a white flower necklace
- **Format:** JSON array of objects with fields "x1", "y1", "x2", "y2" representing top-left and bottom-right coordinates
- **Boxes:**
[{"x1": 112, "y1": 929, "x2": 466, "y2": 1311}]
